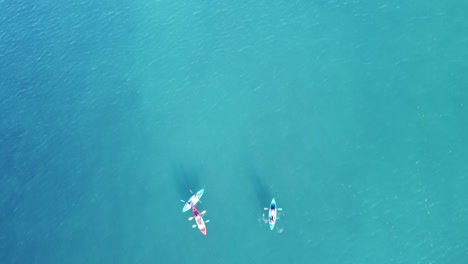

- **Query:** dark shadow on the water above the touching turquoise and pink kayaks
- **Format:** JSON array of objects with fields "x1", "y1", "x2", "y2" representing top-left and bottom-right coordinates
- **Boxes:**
[{"x1": 173, "y1": 165, "x2": 201, "y2": 199}]
